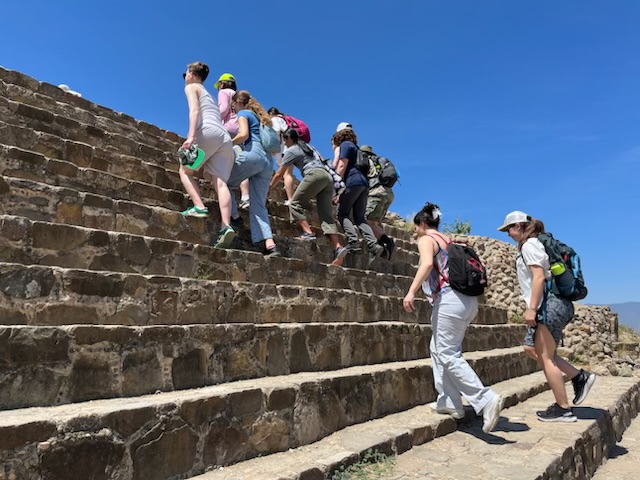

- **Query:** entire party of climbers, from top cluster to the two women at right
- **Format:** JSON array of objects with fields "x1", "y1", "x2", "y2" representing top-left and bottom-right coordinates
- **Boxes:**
[{"x1": 180, "y1": 62, "x2": 596, "y2": 432}]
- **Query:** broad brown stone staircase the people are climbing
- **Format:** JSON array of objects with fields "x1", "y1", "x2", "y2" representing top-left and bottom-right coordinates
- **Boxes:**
[{"x1": 0, "y1": 64, "x2": 640, "y2": 480}]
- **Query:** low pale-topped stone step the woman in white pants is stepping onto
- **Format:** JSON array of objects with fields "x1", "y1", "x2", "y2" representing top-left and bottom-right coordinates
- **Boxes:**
[{"x1": 186, "y1": 372, "x2": 549, "y2": 480}]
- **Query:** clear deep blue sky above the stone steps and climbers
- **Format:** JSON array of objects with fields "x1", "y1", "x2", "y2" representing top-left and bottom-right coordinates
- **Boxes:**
[{"x1": 0, "y1": 0, "x2": 640, "y2": 303}]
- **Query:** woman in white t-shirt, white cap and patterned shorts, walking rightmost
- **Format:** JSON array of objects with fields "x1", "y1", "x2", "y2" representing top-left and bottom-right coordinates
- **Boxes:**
[{"x1": 498, "y1": 210, "x2": 596, "y2": 422}]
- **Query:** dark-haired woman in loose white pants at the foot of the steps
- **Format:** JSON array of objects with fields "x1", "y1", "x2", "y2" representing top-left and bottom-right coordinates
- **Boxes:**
[{"x1": 402, "y1": 203, "x2": 503, "y2": 433}]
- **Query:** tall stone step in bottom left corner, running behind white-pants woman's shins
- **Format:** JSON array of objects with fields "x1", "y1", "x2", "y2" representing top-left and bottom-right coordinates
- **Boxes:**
[{"x1": 0, "y1": 347, "x2": 537, "y2": 480}]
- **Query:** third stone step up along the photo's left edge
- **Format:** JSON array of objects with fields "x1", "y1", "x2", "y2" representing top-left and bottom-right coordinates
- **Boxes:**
[{"x1": 0, "y1": 259, "x2": 507, "y2": 326}]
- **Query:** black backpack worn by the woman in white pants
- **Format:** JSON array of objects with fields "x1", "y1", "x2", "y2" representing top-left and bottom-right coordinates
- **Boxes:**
[{"x1": 432, "y1": 233, "x2": 487, "y2": 297}]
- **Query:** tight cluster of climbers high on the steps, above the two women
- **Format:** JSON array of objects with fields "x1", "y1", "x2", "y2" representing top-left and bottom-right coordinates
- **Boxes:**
[{"x1": 175, "y1": 62, "x2": 395, "y2": 265}]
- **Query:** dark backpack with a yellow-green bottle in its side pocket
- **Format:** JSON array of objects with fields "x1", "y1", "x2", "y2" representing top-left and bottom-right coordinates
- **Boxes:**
[{"x1": 538, "y1": 232, "x2": 589, "y2": 302}]
